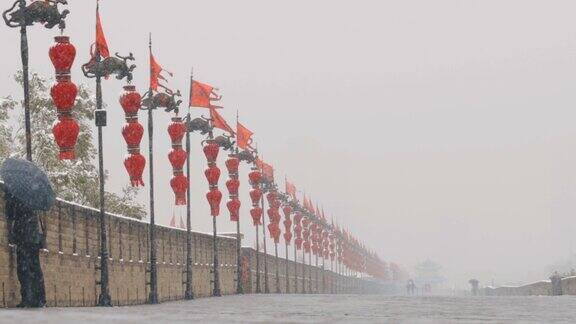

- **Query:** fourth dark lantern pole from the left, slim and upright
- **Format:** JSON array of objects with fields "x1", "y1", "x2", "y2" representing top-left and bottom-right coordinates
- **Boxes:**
[{"x1": 184, "y1": 68, "x2": 194, "y2": 300}]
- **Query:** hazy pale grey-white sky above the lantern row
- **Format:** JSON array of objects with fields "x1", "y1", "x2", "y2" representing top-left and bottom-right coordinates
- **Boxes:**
[{"x1": 0, "y1": 0, "x2": 576, "y2": 283}]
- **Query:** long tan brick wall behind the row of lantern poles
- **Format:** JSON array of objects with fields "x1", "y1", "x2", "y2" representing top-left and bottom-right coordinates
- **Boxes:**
[{"x1": 0, "y1": 190, "x2": 367, "y2": 307}]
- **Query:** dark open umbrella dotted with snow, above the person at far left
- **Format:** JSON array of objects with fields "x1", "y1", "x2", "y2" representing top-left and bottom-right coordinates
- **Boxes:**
[{"x1": 0, "y1": 158, "x2": 55, "y2": 210}]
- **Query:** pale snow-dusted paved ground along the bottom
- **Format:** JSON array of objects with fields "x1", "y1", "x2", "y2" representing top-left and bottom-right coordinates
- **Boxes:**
[{"x1": 0, "y1": 295, "x2": 576, "y2": 324}]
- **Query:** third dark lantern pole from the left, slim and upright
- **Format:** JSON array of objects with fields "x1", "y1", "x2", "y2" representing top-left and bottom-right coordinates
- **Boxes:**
[{"x1": 148, "y1": 33, "x2": 158, "y2": 304}]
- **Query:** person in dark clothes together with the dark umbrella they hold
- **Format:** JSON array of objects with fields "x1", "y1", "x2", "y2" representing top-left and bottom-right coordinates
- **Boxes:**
[{"x1": 0, "y1": 158, "x2": 55, "y2": 307}]
